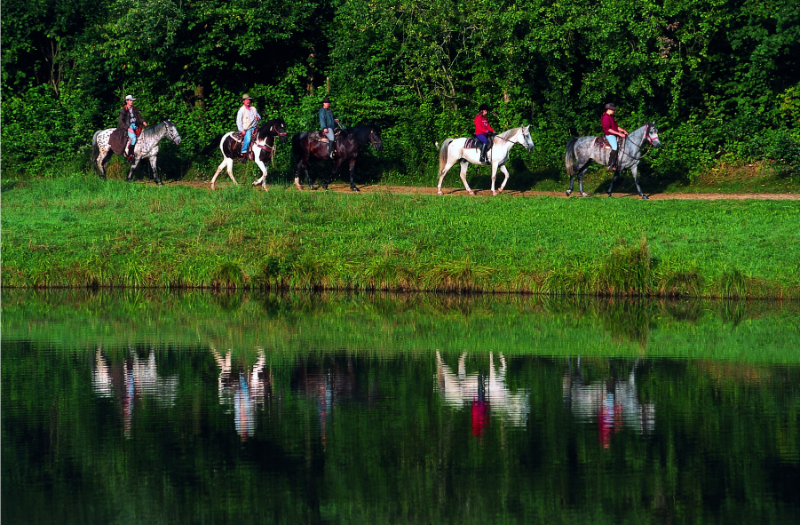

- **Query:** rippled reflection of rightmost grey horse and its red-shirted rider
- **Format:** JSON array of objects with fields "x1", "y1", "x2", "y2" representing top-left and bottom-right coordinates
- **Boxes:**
[{"x1": 563, "y1": 357, "x2": 655, "y2": 448}]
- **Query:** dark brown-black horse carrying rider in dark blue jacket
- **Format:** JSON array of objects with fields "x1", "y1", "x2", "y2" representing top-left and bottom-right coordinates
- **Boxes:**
[{"x1": 292, "y1": 124, "x2": 383, "y2": 191}]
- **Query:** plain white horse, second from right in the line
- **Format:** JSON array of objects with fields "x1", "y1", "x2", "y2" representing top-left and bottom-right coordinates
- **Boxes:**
[{"x1": 436, "y1": 126, "x2": 533, "y2": 195}]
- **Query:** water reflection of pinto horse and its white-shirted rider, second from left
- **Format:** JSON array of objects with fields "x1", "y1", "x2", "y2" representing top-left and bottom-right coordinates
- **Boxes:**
[{"x1": 211, "y1": 348, "x2": 272, "y2": 439}]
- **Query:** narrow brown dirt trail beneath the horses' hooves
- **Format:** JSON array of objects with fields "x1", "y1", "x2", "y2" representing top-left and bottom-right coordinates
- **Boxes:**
[{"x1": 170, "y1": 182, "x2": 800, "y2": 200}]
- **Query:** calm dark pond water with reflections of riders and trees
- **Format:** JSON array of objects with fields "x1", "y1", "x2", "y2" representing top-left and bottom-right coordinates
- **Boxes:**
[{"x1": 2, "y1": 291, "x2": 800, "y2": 524}]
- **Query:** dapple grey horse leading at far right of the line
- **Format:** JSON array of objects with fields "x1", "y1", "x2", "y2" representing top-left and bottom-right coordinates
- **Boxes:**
[{"x1": 564, "y1": 121, "x2": 661, "y2": 199}]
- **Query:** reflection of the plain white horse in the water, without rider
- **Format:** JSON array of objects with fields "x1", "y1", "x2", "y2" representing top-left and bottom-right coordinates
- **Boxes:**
[{"x1": 436, "y1": 350, "x2": 530, "y2": 426}]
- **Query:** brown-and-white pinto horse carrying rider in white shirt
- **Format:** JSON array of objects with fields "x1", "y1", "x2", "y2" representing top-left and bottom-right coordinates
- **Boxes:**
[{"x1": 211, "y1": 118, "x2": 286, "y2": 191}]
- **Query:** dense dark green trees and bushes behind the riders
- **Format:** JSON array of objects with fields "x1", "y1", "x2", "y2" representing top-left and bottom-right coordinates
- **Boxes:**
[{"x1": 2, "y1": 0, "x2": 800, "y2": 182}]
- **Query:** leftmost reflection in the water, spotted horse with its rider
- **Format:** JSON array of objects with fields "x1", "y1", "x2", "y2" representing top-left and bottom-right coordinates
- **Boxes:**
[{"x1": 92, "y1": 348, "x2": 178, "y2": 437}]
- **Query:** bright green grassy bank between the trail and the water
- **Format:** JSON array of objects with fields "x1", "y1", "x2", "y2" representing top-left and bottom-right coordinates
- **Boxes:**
[{"x1": 2, "y1": 176, "x2": 800, "y2": 298}]
